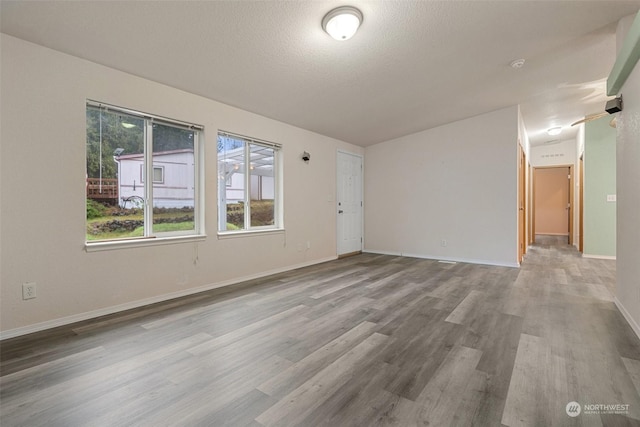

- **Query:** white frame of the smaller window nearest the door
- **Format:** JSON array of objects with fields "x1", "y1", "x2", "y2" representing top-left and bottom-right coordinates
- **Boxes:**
[{"x1": 217, "y1": 130, "x2": 284, "y2": 237}]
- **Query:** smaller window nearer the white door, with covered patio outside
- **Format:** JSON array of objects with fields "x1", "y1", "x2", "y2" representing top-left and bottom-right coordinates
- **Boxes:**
[{"x1": 218, "y1": 132, "x2": 282, "y2": 232}]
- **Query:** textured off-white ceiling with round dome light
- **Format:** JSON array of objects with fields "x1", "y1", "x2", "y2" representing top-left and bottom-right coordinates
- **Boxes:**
[{"x1": 0, "y1": 0, "x2": 640, "y2": 146}]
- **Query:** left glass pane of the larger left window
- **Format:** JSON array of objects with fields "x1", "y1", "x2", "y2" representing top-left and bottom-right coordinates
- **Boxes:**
[{"x1": 86, "y1": 107, "x2": 145, "y2": 241}]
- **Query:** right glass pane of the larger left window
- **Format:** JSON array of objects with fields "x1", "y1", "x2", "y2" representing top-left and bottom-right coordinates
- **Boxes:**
[{"x1": 153, "y1": 123, "x2": 195, "y2": 234}]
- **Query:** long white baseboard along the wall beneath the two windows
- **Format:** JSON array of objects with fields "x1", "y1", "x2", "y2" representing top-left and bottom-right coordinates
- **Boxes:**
[{"x1": 0, "y1": 256, "x2": 337, "y2": 341}]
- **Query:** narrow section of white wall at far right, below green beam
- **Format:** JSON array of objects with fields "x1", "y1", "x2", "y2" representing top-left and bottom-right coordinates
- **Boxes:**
[{"x1": 616, "y1": 19, "x2": 640, "y2": 335}]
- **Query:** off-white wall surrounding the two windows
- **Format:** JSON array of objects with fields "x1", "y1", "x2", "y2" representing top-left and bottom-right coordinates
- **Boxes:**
[{"x1": 0, "y1": 34, "x2": 363, "y2": 337}]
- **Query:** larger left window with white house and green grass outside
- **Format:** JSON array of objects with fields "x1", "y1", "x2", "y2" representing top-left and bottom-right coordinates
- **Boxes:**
[{"x1": 86, "y1": 101, "x2": 201, "y2": 241}]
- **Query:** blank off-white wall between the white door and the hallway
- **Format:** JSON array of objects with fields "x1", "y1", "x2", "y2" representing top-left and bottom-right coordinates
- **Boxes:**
[{"x1": 365, "y1": 106, "x2": 518, "y2": 266}]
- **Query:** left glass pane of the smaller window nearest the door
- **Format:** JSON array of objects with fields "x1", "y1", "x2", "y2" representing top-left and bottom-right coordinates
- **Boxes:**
[{"x1": 218, "y1": 135, "x2": 245, "y2": 231}]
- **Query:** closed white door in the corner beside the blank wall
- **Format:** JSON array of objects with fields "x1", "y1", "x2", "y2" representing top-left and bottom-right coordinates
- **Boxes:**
[{"x1": 336, "y1": 151, "x2": 363, "y2": 255}]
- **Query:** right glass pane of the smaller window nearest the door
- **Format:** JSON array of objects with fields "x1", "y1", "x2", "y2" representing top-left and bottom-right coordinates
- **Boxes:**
[{"x1": 249, "y1": 144, "x2": 275, "y2": 227}]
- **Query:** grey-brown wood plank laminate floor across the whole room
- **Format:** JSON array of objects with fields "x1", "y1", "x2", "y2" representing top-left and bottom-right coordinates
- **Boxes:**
[{"x1": 0, "y1": 237, "x2": 640, "y2": 427}]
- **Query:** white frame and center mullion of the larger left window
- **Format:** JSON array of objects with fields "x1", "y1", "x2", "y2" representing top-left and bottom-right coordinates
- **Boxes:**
[{"x1": 85, "y1": 100, "x2": 206, "y2": 252}]
